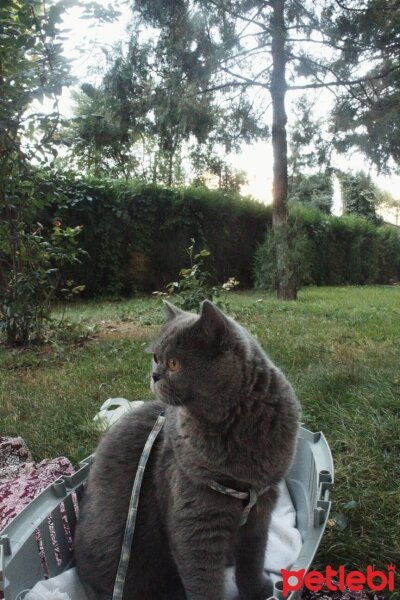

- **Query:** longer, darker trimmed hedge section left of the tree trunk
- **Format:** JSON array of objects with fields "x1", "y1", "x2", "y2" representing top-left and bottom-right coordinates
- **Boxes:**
[{"x1": 47, "y1": 174, "x2": 271, "y2": 296}]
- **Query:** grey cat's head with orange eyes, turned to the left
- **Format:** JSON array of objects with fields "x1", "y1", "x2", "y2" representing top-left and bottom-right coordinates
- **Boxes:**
[{"x1": 151, "y1": 300, "x2": 243, "y2": 421}]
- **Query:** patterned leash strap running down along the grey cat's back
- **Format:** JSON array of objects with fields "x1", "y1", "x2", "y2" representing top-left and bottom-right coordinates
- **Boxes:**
[{"x1": 112, "y1": 413, "x2": 165, "y2": 600}]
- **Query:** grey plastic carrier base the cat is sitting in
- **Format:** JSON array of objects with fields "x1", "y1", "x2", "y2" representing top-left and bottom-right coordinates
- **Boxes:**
[{"x1": 0, "y1": 427, "x2": 333, "y2": 600}]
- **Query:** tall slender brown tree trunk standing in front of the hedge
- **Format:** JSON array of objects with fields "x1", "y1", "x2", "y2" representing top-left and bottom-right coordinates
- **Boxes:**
[{"x1": 271, "y1": 0, "x2": 297, "y2": 300}]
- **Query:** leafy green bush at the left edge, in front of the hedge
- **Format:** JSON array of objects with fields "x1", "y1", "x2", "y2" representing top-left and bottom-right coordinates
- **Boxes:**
[{"x1": 0, "y1": 170, "x2": 84, "y2": 346}]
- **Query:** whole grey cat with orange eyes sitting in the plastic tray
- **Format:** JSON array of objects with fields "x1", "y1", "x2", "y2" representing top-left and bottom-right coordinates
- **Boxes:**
[{"x1": 75, "y1": 301, "x2": 299, "y2": 600}]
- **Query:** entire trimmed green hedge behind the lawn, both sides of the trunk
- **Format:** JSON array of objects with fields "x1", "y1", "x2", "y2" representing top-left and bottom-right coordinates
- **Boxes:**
[{"x1": 41, "y1": 173, "x2": 400, "y2": 296}]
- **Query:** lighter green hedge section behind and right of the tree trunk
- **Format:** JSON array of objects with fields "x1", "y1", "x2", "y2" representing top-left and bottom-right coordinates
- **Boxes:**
[{"x1": 254, "y1": 205, "x2": 400, "y2": 287}]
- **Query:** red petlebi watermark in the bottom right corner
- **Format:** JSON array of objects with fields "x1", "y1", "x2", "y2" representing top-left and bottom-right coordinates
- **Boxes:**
[{"x1": 281, "y1": 564, "x2": 396, "y2": 598}]
